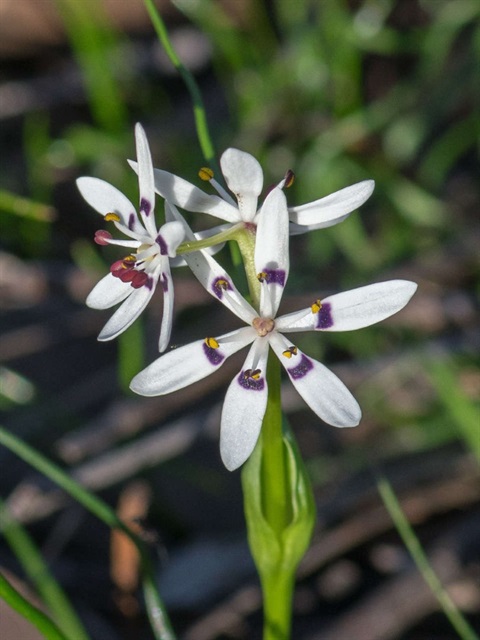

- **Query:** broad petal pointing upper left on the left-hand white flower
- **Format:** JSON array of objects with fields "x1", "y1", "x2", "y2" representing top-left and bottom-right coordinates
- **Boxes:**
[{"x1": 77, "y1": 177, "x2": 138, "y2": 229}]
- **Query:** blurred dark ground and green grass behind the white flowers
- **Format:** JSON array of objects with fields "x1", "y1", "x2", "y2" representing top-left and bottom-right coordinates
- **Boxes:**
[{"x1": 0, "y1": 0, "x2": 480, "y2": 640}]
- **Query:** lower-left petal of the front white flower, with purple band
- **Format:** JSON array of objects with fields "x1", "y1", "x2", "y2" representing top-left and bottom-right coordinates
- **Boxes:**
[{"x1": 130, "y1": 330, "x2": 252, "y2": 396}]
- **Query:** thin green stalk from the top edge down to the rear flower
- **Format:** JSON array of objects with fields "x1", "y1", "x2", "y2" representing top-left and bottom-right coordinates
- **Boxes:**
[{"x1": 144, "y1": 0, "x2": 221, "y2": 170}]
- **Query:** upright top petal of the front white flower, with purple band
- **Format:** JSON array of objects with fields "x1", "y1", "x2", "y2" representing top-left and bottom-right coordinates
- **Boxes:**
[{"x1": 255, "y1": 187, "x2": 290, "y2": 317}]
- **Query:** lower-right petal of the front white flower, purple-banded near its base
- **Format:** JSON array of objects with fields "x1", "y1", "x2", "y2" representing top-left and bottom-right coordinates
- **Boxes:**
[{"x1": 270, "y1": 333, "x2": 362, "y2": 427}]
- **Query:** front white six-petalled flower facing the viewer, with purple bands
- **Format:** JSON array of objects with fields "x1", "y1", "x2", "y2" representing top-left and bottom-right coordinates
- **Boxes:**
[{"x1": 131, "y1": 182, "x2": 416, "y2": 470}]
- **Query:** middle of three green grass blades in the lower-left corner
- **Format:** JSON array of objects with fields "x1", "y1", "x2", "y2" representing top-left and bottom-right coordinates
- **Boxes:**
[{"x1": 0, "y1": 499, "x2": 89, "y2": 640}]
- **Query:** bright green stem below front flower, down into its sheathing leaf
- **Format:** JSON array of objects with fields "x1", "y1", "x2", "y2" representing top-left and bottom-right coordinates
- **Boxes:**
[{"x1": 260, "y1": 352, "x2": 292, "y2": 535}]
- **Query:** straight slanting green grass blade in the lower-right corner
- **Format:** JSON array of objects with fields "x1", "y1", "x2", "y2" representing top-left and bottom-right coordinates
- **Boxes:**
[{"x1": 377, "y1": 477, "x2": 479, "y2": 640}]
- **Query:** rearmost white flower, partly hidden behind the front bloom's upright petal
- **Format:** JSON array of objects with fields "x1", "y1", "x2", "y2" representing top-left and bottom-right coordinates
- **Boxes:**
[{"x1": 140, "y1": 148, "x2": 375, "y2": 235}]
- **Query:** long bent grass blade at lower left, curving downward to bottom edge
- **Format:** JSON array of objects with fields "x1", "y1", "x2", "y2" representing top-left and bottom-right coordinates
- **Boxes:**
[{"x1": 0, "y1": 427, "x2": 175, "y2": 640}]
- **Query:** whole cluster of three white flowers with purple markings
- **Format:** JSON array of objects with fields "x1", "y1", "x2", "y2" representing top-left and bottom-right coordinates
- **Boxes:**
[{"x1": 78, "y1": 125, "x2": 416, "y2": 470}]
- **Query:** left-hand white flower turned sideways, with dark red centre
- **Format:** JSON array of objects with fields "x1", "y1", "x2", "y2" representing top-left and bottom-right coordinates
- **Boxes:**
[{"x1": 77, "y1": 124, "x2": 185, "y2": 351}]
